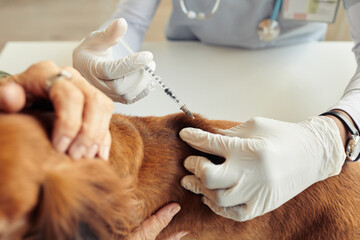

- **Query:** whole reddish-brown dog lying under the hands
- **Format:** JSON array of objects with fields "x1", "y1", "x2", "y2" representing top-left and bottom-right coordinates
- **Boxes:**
[{"x1": 0, "y1": 111, "x2": 360, "y2": 239}]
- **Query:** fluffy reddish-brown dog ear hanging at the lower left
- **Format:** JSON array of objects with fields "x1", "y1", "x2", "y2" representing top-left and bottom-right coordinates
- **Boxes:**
[{"x1": 35, "y1": 160, "x2": 138, "y2": 239}]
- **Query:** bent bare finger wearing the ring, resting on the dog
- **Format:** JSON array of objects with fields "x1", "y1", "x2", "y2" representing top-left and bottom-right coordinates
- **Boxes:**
[{"x1": 5, "y1": 61, "x2": 84, "y2": 155}]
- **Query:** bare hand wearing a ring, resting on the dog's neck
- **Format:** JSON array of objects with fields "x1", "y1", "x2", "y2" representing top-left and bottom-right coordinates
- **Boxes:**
[{"x1": 0, "y1": 61, "x2": 113, "y2": 159}]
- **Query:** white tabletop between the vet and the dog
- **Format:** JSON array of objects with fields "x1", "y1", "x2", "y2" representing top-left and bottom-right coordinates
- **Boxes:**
[{"x1": 0, "y1": 42, "x2": 356, "y2": 122}]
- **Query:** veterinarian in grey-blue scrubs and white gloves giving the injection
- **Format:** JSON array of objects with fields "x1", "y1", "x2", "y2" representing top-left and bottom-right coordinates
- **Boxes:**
[{"x1": 73, "y1": 0, "x2": 360, "y2": 224}]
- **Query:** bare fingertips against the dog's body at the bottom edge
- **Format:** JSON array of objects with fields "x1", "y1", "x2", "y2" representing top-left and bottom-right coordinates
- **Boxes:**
[{"x1": 127, "y1": 203, "x2": 187, "y2": 240}]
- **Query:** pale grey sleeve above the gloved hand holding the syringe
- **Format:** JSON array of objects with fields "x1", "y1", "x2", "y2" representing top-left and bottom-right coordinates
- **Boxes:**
[{"x1": 100, "y1": 0, "x2": 160, "y2": 58}]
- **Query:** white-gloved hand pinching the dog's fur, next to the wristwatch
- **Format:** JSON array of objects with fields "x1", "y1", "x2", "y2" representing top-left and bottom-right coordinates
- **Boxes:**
[{"x1": 180, "y1": 117, "x2": 345, "y2": 221}]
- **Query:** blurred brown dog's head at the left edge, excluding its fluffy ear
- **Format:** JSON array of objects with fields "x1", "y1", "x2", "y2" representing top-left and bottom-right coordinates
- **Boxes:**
[{"x1": 0, "y1": 114, "x2": 46, "y2": 239}]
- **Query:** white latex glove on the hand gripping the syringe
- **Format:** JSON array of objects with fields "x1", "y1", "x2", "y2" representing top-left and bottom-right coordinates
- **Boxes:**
[{"x1": 73, "y1": 19, "x2": 156, "y2": 104}]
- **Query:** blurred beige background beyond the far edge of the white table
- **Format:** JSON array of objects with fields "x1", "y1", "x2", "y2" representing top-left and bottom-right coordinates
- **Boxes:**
[{"x1": 0, "y1": 0, "x2": 351, "y2": 50}]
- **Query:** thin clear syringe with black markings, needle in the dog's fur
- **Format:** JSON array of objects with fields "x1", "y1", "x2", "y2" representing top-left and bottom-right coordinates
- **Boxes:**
[{"x1": 120, "y1": 39, "x2": 195, "y2": 119}]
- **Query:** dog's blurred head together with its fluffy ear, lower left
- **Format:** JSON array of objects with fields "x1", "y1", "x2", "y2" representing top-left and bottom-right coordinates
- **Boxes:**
[{"x1": 0, "y1": 114, "x2": 138, "y2": 239}]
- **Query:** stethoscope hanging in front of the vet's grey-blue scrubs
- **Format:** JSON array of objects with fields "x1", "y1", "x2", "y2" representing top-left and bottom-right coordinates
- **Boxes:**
[{"x1": 179, "y1": 0, "x2": 282, "y2": 42}]
